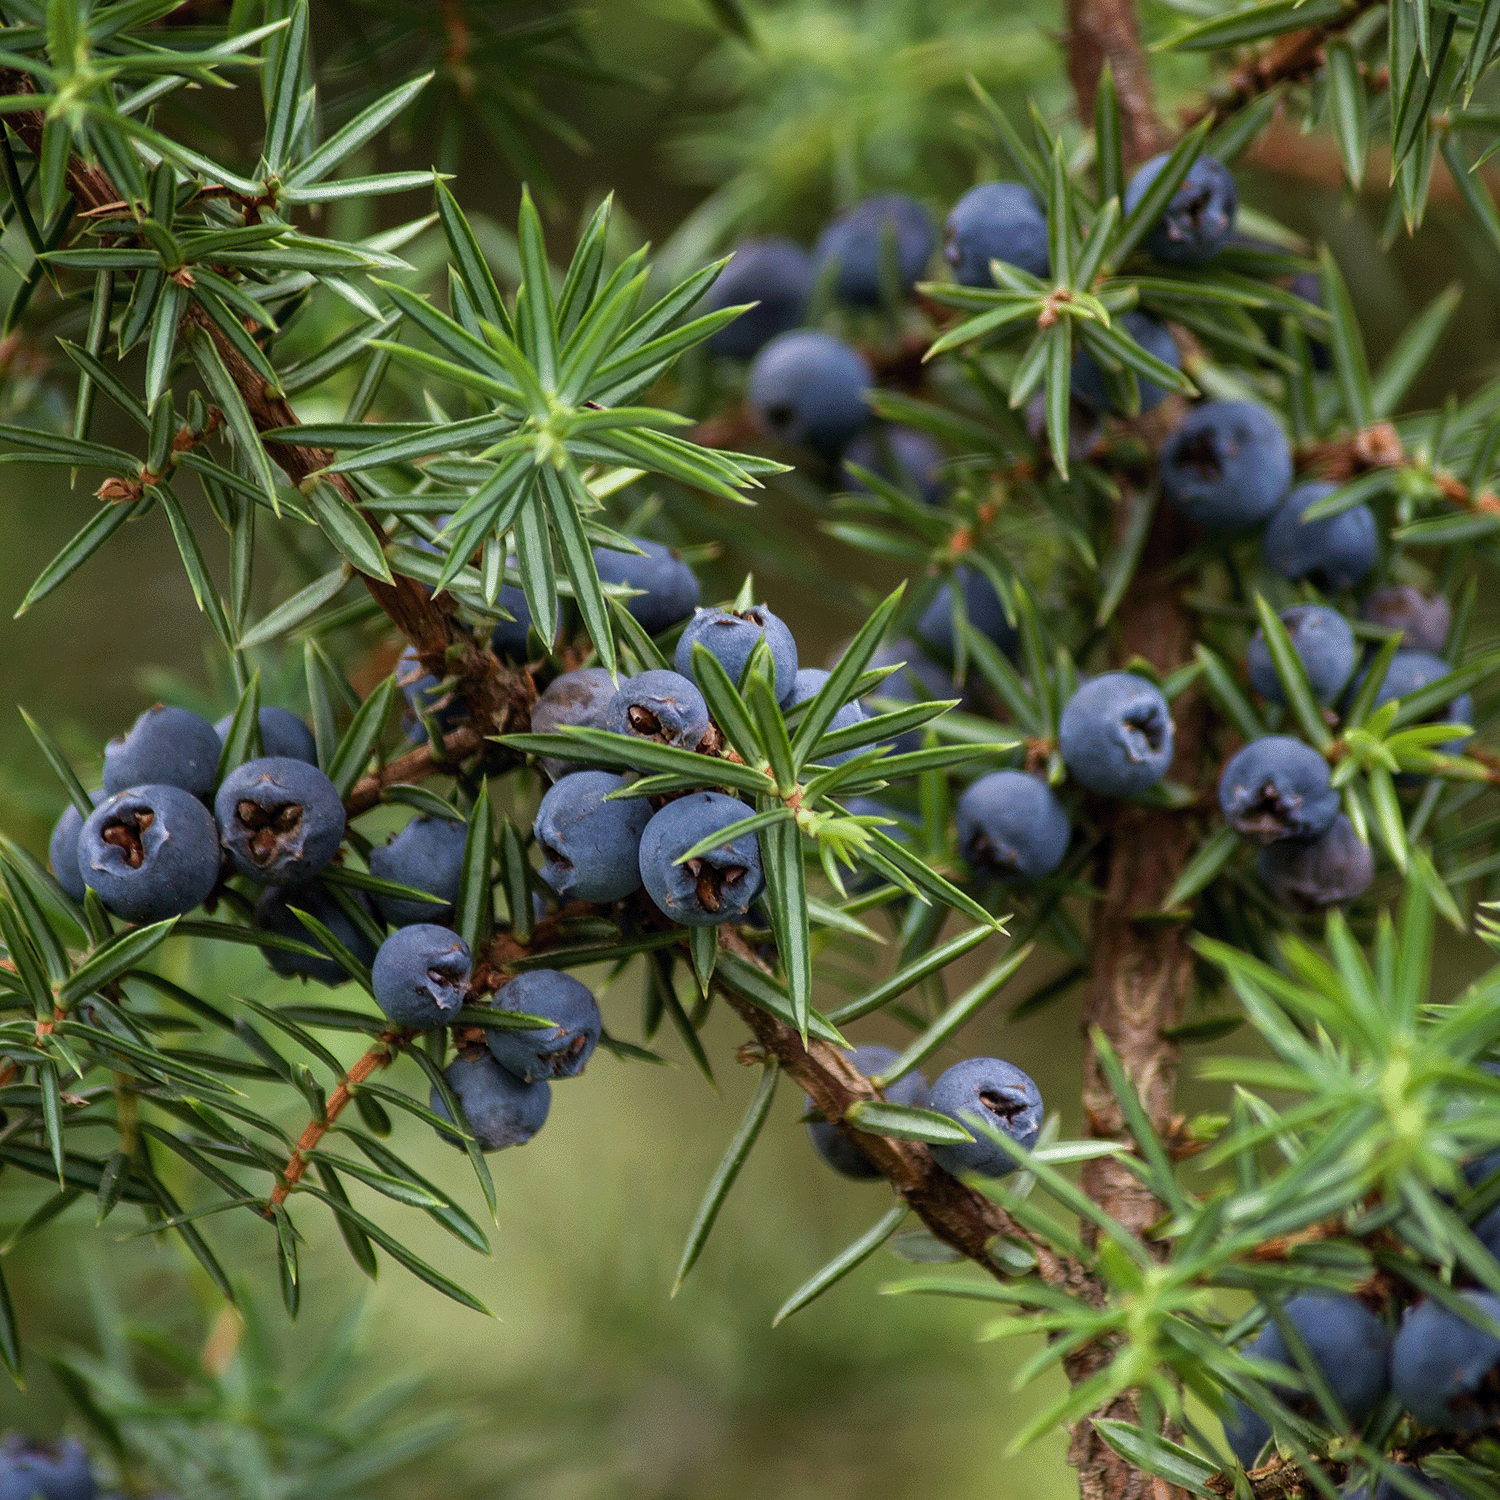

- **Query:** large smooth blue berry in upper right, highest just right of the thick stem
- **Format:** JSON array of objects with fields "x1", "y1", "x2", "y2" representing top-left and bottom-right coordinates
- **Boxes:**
[{"x1": 1161, "y1": 401, "x2": 1292, "y2": 533}]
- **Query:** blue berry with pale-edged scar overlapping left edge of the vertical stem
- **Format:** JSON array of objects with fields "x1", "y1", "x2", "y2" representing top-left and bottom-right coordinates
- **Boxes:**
[{"x1": 1058, "y1": 672, "x2": 1172, "y2": 797}]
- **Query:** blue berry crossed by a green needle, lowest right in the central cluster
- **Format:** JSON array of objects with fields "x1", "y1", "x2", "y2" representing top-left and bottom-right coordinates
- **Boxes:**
[{"x1": 641, "y1": 792, "x2": 765, "y2": 927}]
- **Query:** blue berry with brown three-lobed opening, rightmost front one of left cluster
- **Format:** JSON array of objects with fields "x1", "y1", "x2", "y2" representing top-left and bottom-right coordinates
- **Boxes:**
[{"x1": 213, "y1": 756, "x2": 345, "y2": 885}]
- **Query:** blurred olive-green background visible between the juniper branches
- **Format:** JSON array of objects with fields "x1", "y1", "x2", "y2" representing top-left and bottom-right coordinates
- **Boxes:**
[{"x1": 0, "y1": 0, "x2": 1500, "y2": 1500}]
